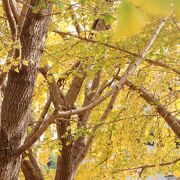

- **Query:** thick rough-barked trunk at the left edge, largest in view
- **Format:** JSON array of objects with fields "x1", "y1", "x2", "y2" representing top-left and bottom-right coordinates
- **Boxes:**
[{"x1": 0, "y1": 0, "x2": 51, "y2": 180}]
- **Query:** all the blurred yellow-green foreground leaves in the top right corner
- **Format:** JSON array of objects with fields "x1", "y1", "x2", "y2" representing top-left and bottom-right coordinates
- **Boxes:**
[{"x1": 113, "y1": 0, "x2": 180, "y2": 41}]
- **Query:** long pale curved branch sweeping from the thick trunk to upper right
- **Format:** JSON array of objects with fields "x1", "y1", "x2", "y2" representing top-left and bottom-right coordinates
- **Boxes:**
[{"x1": 15, "y1": 18, "x2": 167, "y2": 156}]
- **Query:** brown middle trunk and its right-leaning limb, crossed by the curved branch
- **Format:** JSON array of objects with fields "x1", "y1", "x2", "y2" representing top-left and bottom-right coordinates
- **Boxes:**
[{"x1": 55, "y1": 69, "x2": 86, "y2": 180}]
